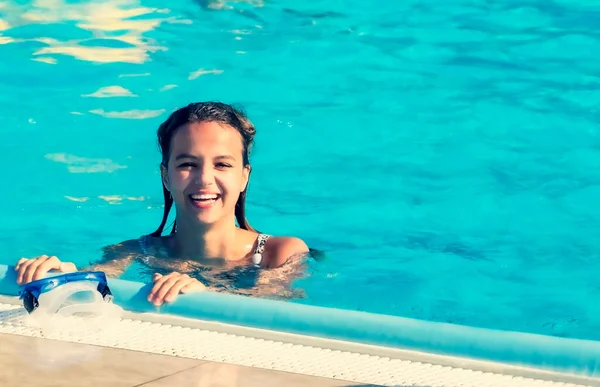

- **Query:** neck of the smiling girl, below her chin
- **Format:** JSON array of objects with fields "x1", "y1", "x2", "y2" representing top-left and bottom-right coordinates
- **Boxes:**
[{"x1": 175, "y1": 215, "x2": 236, "y2": 259}]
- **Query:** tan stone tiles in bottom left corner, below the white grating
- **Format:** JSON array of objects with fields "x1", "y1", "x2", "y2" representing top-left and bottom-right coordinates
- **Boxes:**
[{"x1": 0, "y1": 333, "x2": 394, "y2": 387}]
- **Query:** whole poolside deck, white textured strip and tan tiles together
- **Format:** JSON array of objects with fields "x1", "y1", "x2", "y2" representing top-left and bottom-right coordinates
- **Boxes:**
[{"x1": 0, "y1": 297, "x2": 600, "y2": 387}]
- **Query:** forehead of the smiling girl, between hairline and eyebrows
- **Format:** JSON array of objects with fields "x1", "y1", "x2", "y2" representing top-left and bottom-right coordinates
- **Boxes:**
[{"x1": 171, "y1": 122, "x2": 243, "y2": 157}]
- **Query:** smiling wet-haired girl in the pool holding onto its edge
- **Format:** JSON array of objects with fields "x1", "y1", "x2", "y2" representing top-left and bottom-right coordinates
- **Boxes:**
[{"x1": 15, "y1": 102, "x2": 309, "y2": 305}]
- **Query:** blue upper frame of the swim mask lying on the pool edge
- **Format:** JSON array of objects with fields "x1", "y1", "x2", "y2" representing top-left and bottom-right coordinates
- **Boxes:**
[{"x1": 19, "y1": 271, "x2": 113, "y2": 313}]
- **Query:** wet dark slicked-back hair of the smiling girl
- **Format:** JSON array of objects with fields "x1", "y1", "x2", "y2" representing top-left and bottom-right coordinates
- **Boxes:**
[{"x1": 150, "y1": 102, "x2": 256, "y2": 237}]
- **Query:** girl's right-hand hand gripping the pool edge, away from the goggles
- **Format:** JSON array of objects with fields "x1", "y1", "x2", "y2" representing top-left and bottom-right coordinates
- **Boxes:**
[{"x1": 148, "y1": 272, "x2": 206, "y2": 306}]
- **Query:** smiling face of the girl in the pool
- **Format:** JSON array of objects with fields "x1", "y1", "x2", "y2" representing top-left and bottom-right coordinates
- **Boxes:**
[{"x1": 161, "y1": 122, "x2": 250, "y2": 225}]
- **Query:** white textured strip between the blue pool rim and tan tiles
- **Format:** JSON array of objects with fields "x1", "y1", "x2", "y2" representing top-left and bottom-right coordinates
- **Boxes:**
[{"x1": 0, "y1": 296, "x2": 600, "y2": 387}]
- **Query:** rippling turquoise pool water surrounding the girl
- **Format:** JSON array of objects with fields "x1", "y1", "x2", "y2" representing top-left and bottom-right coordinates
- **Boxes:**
[{"x1": 0, "y1": 0, "x2": 600, "y2": 339}]
